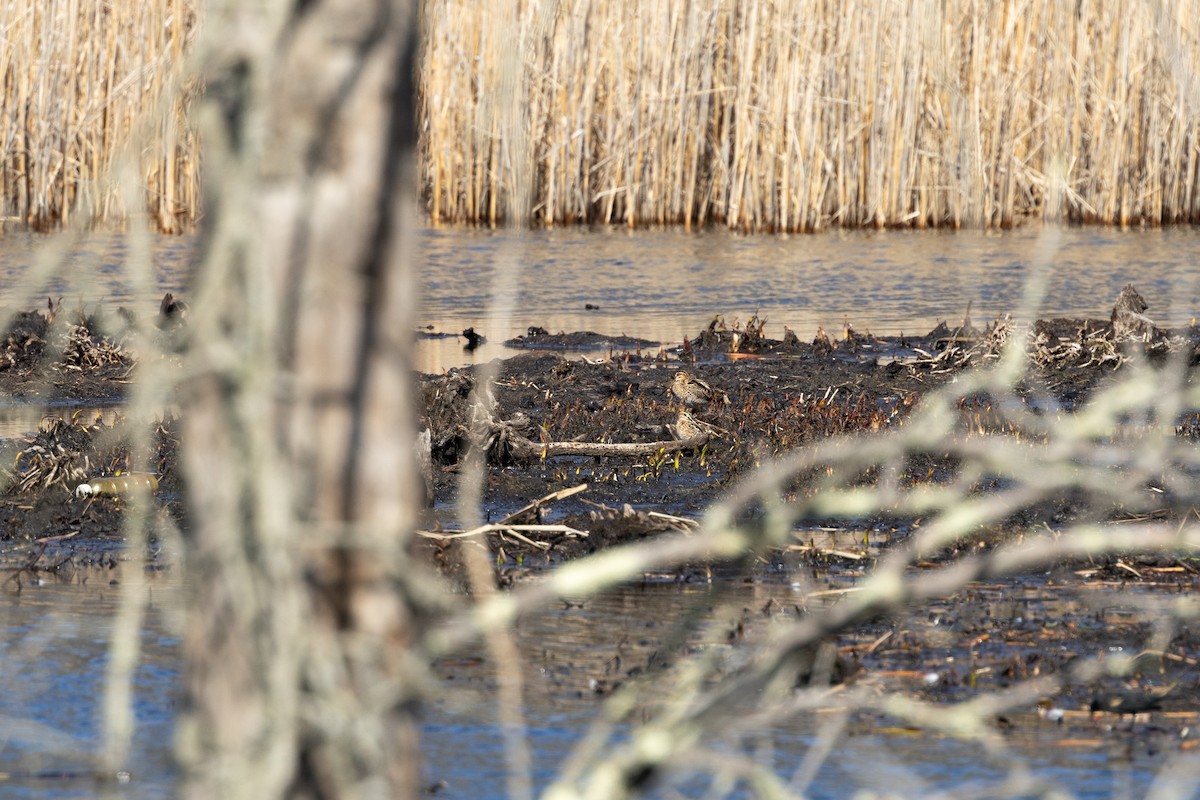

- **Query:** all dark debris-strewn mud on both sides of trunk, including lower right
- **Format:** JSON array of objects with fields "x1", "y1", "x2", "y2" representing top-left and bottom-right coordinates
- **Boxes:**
[{"x1": 7, "y1": 289, "x2": 1200, "y2": 746}]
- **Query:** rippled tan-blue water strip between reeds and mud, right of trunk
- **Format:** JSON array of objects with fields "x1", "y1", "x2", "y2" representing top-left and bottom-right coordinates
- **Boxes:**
[{"x1": 418, "y1": 228, "x2": 1200, "y2": 372}]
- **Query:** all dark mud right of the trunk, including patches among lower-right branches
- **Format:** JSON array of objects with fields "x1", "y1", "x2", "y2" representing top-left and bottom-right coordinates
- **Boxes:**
[{"x1": 419, "y1": 289, "x2": 1200, "y2": 738}]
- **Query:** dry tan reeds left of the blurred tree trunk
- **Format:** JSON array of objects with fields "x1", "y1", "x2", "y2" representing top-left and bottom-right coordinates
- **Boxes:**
[{"x1": 0, "y1": 0, "x2": 199, "y2": 233}]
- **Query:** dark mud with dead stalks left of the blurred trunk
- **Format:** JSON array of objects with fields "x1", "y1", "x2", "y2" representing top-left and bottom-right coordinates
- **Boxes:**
[{"x1": 0, "y1": 295, "x2": 187, "y2": 563}]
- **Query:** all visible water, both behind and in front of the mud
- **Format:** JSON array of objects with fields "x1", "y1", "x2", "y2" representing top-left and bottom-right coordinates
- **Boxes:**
[{"x1": 0, "y1": 228, "x2": 1200, "y2": 798}]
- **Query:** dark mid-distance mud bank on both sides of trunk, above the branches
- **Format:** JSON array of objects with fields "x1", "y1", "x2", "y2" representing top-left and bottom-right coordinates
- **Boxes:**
[{"x1": 0, "y1": 287, "x2": 1200, "y2": 567}]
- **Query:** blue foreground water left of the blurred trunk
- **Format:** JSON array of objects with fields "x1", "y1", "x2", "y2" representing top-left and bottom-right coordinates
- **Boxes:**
[{"x1": 0, "y1": 554, "x2": 180, "y2": 799}]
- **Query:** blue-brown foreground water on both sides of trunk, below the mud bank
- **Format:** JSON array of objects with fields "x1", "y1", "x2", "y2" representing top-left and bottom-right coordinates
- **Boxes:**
[{"x1": 0, "y1": 563, "x2": 1177, "y2": 800}]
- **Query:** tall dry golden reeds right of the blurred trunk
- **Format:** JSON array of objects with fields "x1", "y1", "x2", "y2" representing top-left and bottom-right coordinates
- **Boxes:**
[{"x1": 421, "y1": 0, "x2": 1200, "y2": 231}]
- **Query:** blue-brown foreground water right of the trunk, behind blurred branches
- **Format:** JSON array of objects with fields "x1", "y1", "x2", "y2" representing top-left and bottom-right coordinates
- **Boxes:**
[{"x1": 424, "y1": 570, "x2": 1178, "y2": 798}]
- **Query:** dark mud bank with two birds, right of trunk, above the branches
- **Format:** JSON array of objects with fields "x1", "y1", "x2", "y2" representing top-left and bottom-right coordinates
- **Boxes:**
[{"x1": 421, "y1": 289, "x2": 1200, "y2": 566}]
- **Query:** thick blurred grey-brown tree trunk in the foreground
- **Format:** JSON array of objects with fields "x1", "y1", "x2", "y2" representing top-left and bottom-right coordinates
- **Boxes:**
[{"x1": 179, "y1": 0, "x2": 419, "y2": 800}]
